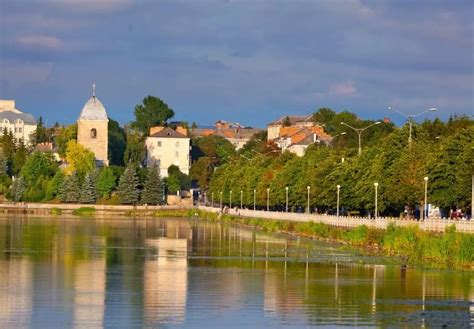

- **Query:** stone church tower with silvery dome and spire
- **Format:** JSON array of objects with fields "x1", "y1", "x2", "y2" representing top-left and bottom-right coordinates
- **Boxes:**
[{"x1": 77, "y1": 84, "x2": 109, "y2": 166}]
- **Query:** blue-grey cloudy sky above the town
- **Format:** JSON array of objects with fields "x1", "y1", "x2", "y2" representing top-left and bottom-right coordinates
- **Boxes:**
[{"x1": 0, "y1": 0, "x2": 474, "y2": 127}]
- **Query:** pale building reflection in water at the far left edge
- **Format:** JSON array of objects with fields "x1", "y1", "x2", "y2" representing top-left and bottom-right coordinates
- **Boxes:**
[{"x1": 0, "y1": 259, "x2": 32, "y2": 328}]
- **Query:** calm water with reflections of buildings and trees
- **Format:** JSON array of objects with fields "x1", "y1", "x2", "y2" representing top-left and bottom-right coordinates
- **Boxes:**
[{"x1": 0, "y1": 216, "x2": 474, "y2": 328}]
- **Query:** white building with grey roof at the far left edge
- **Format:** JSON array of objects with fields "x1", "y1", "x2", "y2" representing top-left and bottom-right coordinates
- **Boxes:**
[{"x1": 0, "y1": 99, "x2": 36, "y2": 145}]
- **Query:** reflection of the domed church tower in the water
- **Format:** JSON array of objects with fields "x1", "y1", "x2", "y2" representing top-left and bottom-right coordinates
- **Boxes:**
[{"x1": 74, "y1": 237, "x2": 106, "y2": 328}]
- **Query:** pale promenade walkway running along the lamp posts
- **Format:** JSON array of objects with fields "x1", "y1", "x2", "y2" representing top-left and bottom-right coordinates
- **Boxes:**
[{"x1": 198, "y1": 205, "x2": 474, "y2": 233}]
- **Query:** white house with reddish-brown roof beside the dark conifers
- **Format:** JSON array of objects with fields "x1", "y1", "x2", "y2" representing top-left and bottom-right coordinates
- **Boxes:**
[{"x1": 145, "y1": 127, "x2": 191, "y2": 177}]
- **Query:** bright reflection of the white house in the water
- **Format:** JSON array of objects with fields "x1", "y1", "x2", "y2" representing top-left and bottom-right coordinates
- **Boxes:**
[{"x1": 143, "y1": 237, "x2": 188, "y2": 325}]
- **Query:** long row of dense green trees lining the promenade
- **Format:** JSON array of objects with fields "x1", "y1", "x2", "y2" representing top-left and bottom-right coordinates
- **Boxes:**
[{"x1": 207, "y1": 109, "x2": 474, "y2": 216}]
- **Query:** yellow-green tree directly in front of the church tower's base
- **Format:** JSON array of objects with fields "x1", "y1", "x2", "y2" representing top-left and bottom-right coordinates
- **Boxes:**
[{"x1": 66, "y1": 140, "x2": 95, "y2": 178}]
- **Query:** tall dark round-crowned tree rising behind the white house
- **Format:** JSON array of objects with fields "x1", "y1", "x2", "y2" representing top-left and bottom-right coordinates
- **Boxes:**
[{"x1": 132, "y1": 96, "x2": 174, "y2": 136}]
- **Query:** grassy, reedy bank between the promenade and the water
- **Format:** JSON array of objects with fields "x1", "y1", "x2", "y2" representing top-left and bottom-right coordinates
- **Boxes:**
[{"x1": 153, "y1": 209, "x2": 474, "y2": 271}]
